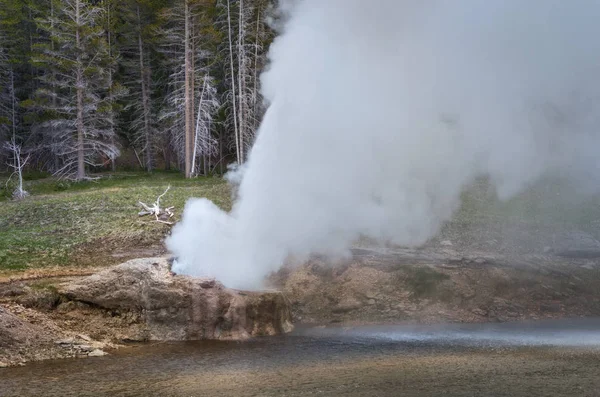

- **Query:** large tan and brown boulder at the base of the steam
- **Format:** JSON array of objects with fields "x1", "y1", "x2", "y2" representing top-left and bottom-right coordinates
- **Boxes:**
[{"x1": 59, "y1": 258, "x2": 292, "y2": 341}]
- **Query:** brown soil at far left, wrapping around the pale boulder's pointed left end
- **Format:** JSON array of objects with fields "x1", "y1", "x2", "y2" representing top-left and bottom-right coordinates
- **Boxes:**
[{"x1": 0, "y1": 238, "x2": 166, "y2": 367}]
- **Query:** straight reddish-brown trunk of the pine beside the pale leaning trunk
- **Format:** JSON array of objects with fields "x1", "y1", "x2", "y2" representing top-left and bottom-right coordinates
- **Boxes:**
[{"x1": 184, "y1": 0, "x2": 194, "y2": 178}]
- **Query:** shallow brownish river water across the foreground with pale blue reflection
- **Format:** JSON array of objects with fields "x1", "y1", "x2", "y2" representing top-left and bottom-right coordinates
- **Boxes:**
[{"x1": 0, "y1": 320, "x2": 600, "y2": 397}]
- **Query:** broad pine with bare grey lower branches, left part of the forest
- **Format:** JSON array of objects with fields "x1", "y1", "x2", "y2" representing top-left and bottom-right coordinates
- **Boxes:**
[{"x1": 34, "y1": 0, "x2": 119, "y2": 180}]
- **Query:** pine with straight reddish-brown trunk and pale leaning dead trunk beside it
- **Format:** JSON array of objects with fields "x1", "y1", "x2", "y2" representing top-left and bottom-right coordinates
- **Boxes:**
[{"x1": 160, "y1": 0, "x2": 219, "y2": 177}]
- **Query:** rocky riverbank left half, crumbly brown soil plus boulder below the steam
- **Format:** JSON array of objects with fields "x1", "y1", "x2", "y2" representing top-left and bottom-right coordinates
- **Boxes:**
[{"x1": 0, "y1": 258, "x2": 292, "y2": 366}]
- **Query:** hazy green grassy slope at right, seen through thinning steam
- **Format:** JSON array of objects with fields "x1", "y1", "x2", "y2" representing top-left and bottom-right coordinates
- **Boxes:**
[{"x1": 442, "y1": 180, "x2": 600, "y2": 252}]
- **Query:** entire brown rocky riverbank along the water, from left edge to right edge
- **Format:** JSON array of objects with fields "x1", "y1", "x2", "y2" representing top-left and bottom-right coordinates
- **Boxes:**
[{"x1": 0, "y1": 232, "x2": 600, "y2": 366}]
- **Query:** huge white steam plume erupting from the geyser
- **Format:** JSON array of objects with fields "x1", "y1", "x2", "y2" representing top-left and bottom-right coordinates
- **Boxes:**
[{"x1": 168, "y1": 0, "x2": 600, "y2": 288}]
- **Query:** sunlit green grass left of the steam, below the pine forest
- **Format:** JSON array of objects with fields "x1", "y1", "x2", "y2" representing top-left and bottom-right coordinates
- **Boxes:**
[{"x1": 0, "y1": 173, "x2": 231, "y2": 272}]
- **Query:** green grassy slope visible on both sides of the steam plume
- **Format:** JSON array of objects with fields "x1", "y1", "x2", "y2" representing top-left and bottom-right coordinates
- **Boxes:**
[{"x1": 0, "y1": 173, "x2": 600, "y2": 275}]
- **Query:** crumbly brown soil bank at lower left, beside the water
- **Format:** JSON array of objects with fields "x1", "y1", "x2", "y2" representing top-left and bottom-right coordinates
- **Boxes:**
[{"x1": 0, "y1": 278, "x2": 136, "y2": 367}]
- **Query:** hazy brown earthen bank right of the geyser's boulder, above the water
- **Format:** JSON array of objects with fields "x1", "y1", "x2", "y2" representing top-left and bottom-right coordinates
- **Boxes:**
[{"x1": 271, "y1": 249, "x2": 600, "y2": 324}]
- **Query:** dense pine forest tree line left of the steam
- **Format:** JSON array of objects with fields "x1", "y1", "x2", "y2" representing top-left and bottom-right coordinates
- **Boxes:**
[{"x1": 0, "y1": 0, "x2": 273, "y2": 180}]
